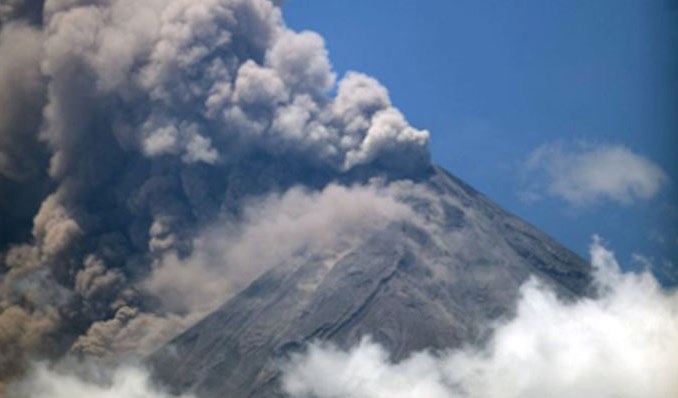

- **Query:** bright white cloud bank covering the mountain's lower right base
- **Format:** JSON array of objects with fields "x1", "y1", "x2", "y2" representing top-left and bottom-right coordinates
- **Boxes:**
[{"x1": 282, "y1": 237, "x2": 678, "y2": 398}]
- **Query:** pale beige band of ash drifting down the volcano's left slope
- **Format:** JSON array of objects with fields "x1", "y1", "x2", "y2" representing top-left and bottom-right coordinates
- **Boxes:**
[{"x1": 73, "y1": 184, "x2": 412, "y2": 356}]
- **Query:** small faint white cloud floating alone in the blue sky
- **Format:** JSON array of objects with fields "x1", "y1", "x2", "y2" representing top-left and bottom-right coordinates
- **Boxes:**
[{"x1": 525, "y1": 144, "x2": 668, "y2": 206}]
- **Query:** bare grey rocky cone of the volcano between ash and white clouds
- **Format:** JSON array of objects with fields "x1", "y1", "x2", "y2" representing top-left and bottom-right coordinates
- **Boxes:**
[{"x1": 149, "y1": 169, "x2": 591, "y2": 397}]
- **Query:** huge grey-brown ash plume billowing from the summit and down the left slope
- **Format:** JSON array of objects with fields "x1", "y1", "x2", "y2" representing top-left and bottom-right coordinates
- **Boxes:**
[{"x1": 0, "y1": 0, "x2": 429, "y2": 388}]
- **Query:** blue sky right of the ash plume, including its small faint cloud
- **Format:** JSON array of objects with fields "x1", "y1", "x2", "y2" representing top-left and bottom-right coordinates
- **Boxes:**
[{"x1": 284, "y1": 0, "x2": 678, "y2": 282}]
